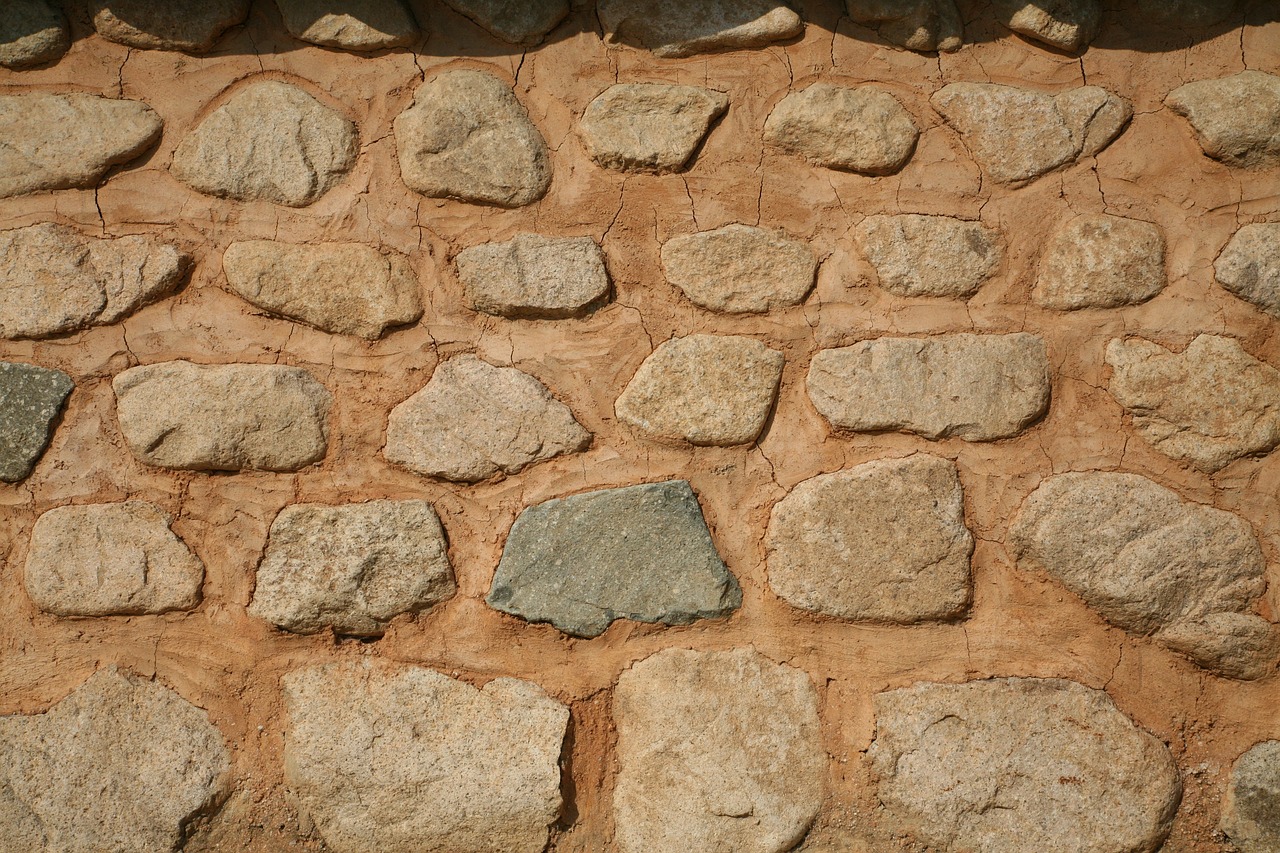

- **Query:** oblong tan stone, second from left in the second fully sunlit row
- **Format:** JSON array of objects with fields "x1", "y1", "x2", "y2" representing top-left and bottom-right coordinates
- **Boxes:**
[{"x1": 223, "y1": 240, "x2": 422, "y2": 341}]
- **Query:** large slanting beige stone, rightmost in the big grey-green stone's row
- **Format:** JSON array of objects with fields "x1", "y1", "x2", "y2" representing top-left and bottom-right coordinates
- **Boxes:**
[{"x1": 1010, "y1": 473, "x2": 1280, "y2": 678}]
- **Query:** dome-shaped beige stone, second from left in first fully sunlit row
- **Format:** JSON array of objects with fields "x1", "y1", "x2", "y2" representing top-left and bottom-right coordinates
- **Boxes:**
[{"x1": 169, "y1": 81, "x2": 360, "y2": 207}]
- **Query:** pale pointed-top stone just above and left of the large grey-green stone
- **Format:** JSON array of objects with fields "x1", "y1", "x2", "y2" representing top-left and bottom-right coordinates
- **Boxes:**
[{"x1": 384, "y1": 355, "x2": 591, "y2": 483}]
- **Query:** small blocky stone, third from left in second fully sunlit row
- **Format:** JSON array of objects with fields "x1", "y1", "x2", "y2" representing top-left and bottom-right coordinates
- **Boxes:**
[{"x1": 454, "y1": 234, "x2": 609, "y2": 320}]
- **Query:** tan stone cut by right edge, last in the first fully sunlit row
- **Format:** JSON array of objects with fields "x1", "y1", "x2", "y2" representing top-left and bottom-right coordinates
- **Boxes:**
[{"x1": 1165, "y1": 70, "x2": 1280, "y2": 169}]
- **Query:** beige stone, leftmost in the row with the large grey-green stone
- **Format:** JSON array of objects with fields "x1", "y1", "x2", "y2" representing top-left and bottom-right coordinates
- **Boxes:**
[{"x1": 24, "y1": 501, "x2": 205, "y2": 616}]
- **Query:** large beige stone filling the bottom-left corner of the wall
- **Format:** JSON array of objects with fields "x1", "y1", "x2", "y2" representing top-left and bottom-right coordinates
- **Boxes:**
[{"x1": 0, "y1": 667, "x2": 230, "y2": 853}]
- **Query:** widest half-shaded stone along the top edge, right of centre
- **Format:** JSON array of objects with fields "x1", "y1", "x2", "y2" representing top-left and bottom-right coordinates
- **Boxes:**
[{"x1": 596, "y1": 0, "x2": 804, "y2": 59}]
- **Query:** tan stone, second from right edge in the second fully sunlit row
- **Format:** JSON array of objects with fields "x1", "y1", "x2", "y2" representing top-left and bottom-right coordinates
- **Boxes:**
[{"x1": 1032, "y1": 214, "x2": 1165, "y2": 311}]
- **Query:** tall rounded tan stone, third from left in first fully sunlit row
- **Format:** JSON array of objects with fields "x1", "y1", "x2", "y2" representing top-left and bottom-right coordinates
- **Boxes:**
[{"x1": 393, "y1": 70, "x2": 552, "y2": 207}]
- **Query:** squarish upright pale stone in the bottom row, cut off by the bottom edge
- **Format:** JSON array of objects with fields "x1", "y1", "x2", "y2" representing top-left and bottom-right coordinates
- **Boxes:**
[{"x1": 613, "y1": 648, "x2": 827, "y2": 853}]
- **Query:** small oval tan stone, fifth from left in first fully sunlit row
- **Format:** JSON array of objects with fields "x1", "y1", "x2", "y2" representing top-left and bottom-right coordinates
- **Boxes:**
[{"x1": 764, "y1": 83, "x2": 920, "y2": 174}]
